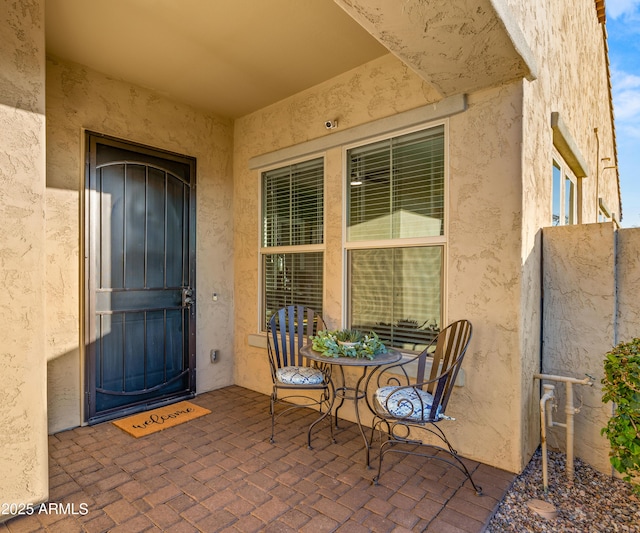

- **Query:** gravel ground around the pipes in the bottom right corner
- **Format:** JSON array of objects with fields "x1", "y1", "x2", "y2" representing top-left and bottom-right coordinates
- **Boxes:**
[{"x1": 485, "y1": 449, "x2": 640, "y2": 533}]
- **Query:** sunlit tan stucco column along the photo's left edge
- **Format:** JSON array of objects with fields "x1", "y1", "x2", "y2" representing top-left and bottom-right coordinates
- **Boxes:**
[{"x1": 0, "y1": 0, "x2": 49, "y2": 522}]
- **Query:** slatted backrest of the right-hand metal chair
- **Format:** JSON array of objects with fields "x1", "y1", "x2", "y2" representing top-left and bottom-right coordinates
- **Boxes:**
[{"x1": 416, "y1": 320, "x2": 473, "y2": 416}]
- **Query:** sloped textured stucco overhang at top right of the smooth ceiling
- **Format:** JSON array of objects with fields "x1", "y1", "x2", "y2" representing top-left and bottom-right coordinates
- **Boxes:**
[{"x1": 334, "y1": 0, "x2": 536, "y2": 97}]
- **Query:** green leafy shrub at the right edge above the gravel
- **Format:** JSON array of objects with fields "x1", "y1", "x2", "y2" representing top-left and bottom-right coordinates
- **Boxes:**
[{"x1": 601, "y1": 339, "x2": 640, "y2": 495}]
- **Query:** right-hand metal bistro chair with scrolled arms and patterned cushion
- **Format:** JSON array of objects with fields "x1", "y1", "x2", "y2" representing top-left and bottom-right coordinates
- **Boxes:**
[{"x1": 365, "y1": 320, "x2": 482, "y2": 495}]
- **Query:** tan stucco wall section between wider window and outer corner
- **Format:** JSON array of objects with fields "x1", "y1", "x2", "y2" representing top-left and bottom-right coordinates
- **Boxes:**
[{"x1": 447, "y1": 83, "x2": 524, "y2": 472}]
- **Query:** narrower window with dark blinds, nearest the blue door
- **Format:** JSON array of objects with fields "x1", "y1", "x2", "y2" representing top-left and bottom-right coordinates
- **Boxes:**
[{"x1": 261, "y1": 158, "x2": 324, "y2": 328}]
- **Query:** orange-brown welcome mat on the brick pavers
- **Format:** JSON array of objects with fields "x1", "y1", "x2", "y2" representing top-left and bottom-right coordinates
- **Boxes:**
[{"x1": 112, "y1": 402, "x2": 211, "y2": 439}]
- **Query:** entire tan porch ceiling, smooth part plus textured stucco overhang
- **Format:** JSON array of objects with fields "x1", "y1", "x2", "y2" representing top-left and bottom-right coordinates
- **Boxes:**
[{"x1": 45, "y1": 0, "x2": 536, "y2": 118}]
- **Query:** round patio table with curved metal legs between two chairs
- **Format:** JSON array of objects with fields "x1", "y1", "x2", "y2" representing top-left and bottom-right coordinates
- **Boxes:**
[{"x1": 300, "y1": 344, "x2": 402, "y2": 468}]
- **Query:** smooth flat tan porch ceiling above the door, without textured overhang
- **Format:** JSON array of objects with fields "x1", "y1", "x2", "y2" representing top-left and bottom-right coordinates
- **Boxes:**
[{"x1": 45, "y1": 0, "x2": 389, "y2": 118}]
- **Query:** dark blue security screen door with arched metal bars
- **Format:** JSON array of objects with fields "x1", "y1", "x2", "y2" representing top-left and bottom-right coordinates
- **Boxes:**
[{"x1": 84, "y1": 133, "x2": 196, "y2": 423}]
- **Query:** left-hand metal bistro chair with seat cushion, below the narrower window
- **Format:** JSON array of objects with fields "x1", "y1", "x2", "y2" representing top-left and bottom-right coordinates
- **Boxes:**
[{"x1": 267, "y1": 305, "x2": 335, "y2": 449}]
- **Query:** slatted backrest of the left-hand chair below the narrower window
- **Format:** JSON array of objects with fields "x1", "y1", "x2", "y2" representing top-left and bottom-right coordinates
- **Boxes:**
[{"x1": 267, "y1": 305, "x2": 325, "y2": 368}]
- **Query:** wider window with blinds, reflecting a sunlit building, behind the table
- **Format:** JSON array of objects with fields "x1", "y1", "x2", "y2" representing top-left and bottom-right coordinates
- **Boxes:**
[{"x1": 347, "y1": 126, "x2": 446, "y2": 350}]
